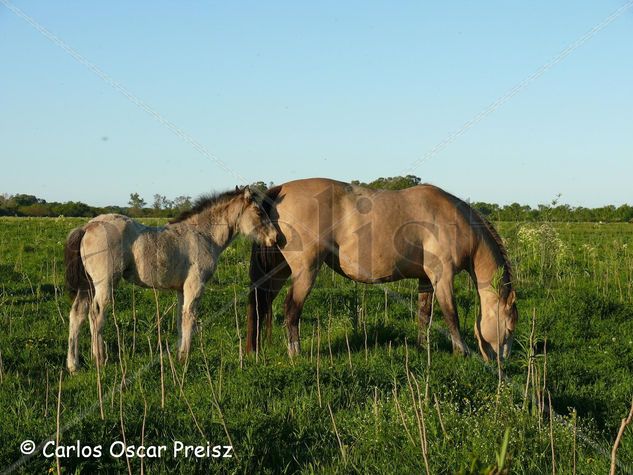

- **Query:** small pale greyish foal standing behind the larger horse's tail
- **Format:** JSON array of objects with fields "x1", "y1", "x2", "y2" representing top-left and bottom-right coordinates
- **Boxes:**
[{"x1": 65, "y1": 187, "x2": 277, "y2": 372}]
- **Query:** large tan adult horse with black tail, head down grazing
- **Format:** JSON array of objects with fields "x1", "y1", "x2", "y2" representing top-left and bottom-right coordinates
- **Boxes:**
[{"x1": 247, "y1": 178, "x2": 518, "y2": 360}]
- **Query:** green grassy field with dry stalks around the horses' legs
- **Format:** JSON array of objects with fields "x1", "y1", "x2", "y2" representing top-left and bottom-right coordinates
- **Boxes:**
[{"x1": 0, "y1": 218, "x2": 633, "y2": 474}]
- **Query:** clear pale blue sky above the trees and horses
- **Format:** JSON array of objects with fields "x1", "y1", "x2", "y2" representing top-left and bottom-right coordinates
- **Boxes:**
[{"x1": 0, "y1": 0, "x2": 633, "y2": 206}]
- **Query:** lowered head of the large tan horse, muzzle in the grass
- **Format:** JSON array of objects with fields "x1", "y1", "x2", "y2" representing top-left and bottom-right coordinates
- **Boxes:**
[{"x1": 475, "y1": 284, "x2": 519, "y2": 361}]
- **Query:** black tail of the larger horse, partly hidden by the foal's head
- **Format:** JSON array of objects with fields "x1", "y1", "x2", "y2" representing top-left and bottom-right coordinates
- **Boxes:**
[{"x1": 246, "y1": 186, "x2": 285, "y2": 352}]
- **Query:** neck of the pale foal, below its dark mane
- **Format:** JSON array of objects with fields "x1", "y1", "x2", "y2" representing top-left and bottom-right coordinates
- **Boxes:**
[{"x1": 184, "y1": 202, "x2": 239, "y2": 250}]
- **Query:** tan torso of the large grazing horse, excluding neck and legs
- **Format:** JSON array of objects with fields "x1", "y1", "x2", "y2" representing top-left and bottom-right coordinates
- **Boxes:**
[{"x1": 271, "y1": 178, "x2": 474, "y2": 282}]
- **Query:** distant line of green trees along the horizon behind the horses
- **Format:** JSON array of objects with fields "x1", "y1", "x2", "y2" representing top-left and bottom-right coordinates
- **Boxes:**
[{"x1": 0, "y1": 175, "x2": 633, "y2": 223}]
